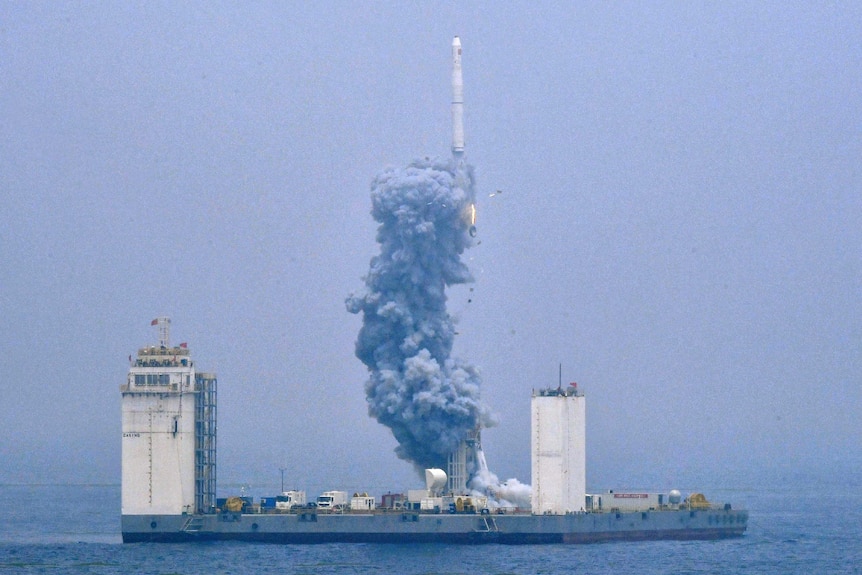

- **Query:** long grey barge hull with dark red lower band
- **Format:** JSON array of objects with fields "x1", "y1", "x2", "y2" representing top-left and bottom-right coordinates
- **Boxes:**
[{"x1": 122, "y1": 510, "x2": 748, "y2": 545}]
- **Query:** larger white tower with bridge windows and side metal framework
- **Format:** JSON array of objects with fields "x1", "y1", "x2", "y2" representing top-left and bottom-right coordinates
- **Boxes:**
[{"x1": 120, "y1": 317, "x2": 216, "y2": 515}]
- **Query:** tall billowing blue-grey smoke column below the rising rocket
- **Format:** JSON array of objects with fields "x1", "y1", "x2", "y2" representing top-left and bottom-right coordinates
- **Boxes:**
[{"x1": 346, "y1": 158, "x2": 491, "y2": 472}]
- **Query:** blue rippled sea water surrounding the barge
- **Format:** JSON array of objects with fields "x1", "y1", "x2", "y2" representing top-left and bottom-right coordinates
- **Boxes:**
[{"x1": 0, "y1": 485, "x2": 862, "y2": 575}]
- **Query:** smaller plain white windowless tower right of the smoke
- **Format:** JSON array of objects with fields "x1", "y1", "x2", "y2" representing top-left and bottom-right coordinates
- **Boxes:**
[{"x1": 530, "y1": 384, "x2": 587, "y2": 514}]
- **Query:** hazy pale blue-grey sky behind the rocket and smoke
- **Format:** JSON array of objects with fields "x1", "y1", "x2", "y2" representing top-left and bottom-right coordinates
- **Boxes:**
[{"x1": 0, "y1": 1, "x2": 862, "y2": 494}]
